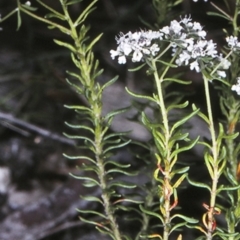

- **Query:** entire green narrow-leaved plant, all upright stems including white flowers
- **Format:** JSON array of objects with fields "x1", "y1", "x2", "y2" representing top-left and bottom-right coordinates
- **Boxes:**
[{"x1": 2, "y1": 0, "x2": 240, "y2": 240}]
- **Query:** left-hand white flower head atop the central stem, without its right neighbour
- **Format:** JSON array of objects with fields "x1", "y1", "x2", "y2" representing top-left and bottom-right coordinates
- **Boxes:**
[{"x1": 110, "y1": 30, "x2": 162, "y2": 64}]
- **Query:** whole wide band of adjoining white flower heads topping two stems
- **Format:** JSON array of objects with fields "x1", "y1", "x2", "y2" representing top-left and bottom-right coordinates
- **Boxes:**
[{"x1": 110, "y1": 17, "x2": 230, "y2": 77}]
